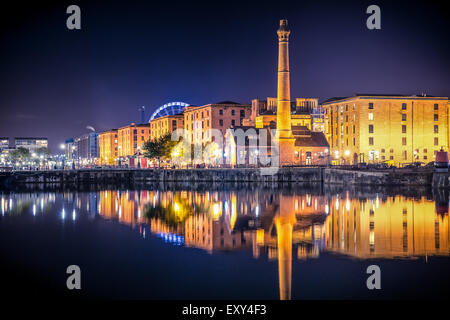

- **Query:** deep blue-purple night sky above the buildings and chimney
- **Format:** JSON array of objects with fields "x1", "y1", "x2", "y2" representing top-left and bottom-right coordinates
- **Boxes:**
[{"x1": 0, "y1": 0, "x2": 450, "y2": 152}]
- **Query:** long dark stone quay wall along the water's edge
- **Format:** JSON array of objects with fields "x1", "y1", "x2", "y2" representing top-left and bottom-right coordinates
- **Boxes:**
[{"x1": 0, "y1": 167, "x2": 436, "y2": 188}]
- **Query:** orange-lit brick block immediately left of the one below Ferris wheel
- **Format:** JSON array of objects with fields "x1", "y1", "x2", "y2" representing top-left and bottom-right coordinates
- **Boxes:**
[{"x1": 117, "y1": 123, "x2": 151, "y2": 158}]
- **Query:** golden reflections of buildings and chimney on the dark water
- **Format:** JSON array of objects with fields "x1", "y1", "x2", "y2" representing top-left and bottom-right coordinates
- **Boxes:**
[{"x1": 0, "y1": 190, "x2": 450, "y2": 299}]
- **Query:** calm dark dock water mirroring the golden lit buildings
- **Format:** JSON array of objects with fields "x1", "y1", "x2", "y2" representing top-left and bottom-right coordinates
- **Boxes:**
[{"x1": 0, "y1": 187, "x2": 450, "y2": 299}]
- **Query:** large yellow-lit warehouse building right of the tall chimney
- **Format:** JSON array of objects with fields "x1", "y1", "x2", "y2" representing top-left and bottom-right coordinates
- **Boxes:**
[{"x1": 322, "y1": 95, "x2": 449, "y2": 165}]
